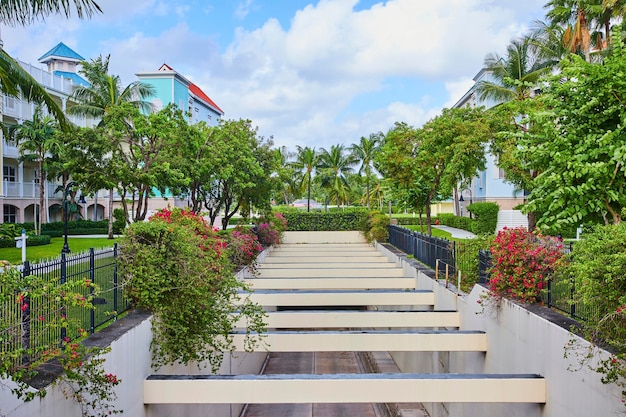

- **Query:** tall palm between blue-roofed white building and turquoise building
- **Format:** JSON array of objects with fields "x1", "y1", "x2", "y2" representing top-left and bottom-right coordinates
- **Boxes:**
[{"x1": 67, "y1": 55, "x2": 155, "y2": 239}]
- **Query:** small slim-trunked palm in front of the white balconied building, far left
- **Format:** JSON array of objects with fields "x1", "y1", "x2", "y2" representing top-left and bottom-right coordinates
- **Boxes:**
[{"x1": 9, "y1": 106, "x2": 60, "y2": 234}]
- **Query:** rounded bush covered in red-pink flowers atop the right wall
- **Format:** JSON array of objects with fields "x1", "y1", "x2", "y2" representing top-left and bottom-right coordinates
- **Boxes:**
[{"x1": 489, "y1": 228, "x2": 564, "y2": 303}]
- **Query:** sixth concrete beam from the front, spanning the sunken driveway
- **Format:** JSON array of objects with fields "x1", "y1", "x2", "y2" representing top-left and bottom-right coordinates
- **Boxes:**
[{"x1": 258, "y1": 264, "x2": 404, "y2": 278}]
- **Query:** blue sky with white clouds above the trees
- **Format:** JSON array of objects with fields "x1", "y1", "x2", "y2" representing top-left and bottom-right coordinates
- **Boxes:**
[{"x1": 1, "y1": 0, "x2": 545, "y2": 149}]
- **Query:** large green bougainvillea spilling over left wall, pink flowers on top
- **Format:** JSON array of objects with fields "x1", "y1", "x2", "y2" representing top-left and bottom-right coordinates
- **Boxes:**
[{"x1": 120, "y1": 208, "x2": 265, "y2": 371}]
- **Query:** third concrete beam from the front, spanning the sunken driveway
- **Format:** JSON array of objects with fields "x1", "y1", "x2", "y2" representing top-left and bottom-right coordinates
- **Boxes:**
[{"x1": 238, "y1": 310, "x2": 461, "y2": 329}]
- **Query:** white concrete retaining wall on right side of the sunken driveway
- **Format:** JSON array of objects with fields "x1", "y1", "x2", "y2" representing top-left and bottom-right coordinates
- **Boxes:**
[{"x1": 378, "y1": 240, "x2": 626, "y2": 417}]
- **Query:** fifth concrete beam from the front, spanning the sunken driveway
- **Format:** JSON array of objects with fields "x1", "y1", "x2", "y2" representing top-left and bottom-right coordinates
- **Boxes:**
[{"x1": 244, "y1": 277, "x2": 416, "y2": 290}]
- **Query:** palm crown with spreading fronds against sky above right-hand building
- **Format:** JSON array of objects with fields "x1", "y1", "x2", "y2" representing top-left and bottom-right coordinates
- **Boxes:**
[{"x1": 476, "y1": 37, "x2": 552, "y2": 103}]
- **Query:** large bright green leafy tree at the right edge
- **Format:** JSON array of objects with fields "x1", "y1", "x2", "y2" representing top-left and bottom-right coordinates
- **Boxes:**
[{"x1": 520, "y1": 35, "x2": 626, "y2": 227}]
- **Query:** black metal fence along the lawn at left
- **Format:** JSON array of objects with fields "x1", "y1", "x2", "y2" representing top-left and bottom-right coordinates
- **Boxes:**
[{"x1": 0, "y1": 244, "x2": 129, "y2": 360}]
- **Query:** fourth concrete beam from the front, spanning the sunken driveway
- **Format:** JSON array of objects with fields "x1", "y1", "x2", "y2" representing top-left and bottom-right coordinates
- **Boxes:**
[{"x1": 240, "y1": 290, "x2": 435, "y2": 307}]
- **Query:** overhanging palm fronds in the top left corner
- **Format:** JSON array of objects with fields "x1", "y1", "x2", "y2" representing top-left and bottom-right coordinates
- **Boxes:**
[{"x1": 0, "y1": 0, "x2": 101, "y2": 129}]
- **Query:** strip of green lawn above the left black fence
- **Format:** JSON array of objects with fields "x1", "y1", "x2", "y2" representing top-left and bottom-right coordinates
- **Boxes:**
[{"x1": 0, "y1": 236, "x2": 118, "y2": 264}]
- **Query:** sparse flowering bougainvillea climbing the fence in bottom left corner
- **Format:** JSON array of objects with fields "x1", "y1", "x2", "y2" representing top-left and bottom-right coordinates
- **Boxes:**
[{"x1": 0, "y1": 261, "x2": 121, "y2": 417}]
